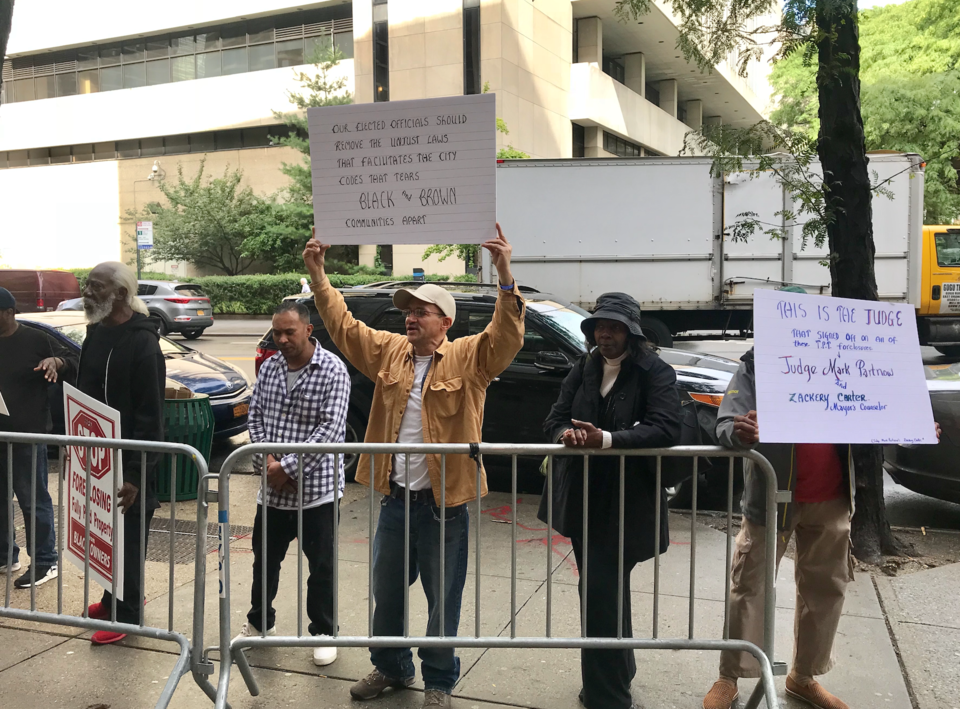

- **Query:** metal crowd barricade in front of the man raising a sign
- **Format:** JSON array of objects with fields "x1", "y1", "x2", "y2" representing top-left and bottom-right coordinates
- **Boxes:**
[{"x1": 194, "y1": 443, "x2": 784, "y2": 709}]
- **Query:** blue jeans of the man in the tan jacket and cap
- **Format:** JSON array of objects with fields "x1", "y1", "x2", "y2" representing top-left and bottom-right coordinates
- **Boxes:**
[{"x1": 370, "y1": 497, "x2": 470, "y2": 694}]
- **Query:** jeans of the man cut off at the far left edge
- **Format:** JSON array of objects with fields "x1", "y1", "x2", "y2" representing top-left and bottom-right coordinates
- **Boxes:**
[{"x1": 0, "y1": 443, "x2": 57, "y2": 567}]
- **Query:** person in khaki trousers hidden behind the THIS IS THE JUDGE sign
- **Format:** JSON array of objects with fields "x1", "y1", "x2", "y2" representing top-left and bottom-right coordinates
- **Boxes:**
[{"x1": 703, "y1": 290, "x2": 940, "y2": 709}]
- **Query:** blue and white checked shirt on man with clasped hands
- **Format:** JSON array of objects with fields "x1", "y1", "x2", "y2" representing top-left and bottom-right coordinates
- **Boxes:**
[{"x1": 247, "y1": 340, "x2": 350, "y2": 510}]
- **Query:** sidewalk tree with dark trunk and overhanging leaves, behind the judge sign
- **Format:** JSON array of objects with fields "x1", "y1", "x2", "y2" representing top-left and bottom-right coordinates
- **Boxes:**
[{"x1": 615, "y1": 0, "x2": 899, "y2": 561}]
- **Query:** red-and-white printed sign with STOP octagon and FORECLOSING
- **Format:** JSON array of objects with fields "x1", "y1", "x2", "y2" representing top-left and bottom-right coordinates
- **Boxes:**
[{"x1": 63, "y1": 383, "x2": 123, "y2": 601}]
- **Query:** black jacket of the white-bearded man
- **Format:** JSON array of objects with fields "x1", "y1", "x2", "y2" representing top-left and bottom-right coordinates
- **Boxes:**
[{"x1": 77, "y1": 313, "x2": 167, "y2": 512}]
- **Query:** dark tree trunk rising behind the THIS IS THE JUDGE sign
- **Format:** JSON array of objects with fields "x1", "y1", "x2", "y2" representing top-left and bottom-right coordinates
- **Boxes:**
[{"x1": 816, "y1": 0, "x2": 899, "y2": 563}]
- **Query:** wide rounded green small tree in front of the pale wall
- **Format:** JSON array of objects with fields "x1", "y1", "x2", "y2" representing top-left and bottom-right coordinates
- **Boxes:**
[{"x1": 135, "y1": 161, "x2": 272, "y2": 276}]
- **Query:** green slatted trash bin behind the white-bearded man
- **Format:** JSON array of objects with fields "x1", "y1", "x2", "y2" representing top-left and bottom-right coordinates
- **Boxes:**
[{"x1": 157, "y1": 394, "x2": 214, "y2": 502}]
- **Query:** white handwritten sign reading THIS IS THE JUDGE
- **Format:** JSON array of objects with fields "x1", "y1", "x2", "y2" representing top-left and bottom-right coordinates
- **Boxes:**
[{"x1": 753, "y1": 290, "x2": 937, "y2": 444}]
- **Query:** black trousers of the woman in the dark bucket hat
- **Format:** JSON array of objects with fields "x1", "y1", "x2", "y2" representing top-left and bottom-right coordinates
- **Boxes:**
[{"x1": 570, "y1": 534, "x2": 637, "y2": 709}]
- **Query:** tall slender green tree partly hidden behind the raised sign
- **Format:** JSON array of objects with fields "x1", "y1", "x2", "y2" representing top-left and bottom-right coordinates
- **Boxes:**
[{"x1": 247, "y1": 42, "x2": 357, "y2": 273}]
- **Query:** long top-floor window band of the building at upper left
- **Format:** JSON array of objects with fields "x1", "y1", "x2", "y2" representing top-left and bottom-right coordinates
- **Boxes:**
[{"x1": 0, "y1": 4, "x2": 356, "y2": 103}]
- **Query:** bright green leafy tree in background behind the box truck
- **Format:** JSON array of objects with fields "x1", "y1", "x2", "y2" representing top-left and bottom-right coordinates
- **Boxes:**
[{"x1": 770, "y1": 0, "x2": 960, "y2": 224}]
